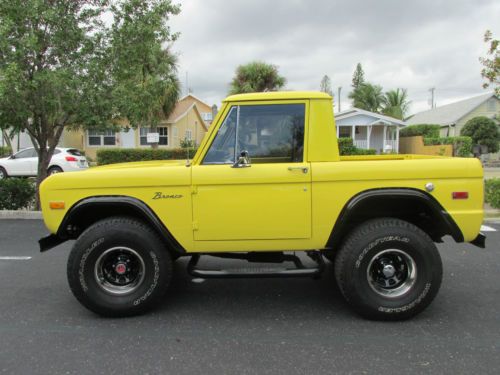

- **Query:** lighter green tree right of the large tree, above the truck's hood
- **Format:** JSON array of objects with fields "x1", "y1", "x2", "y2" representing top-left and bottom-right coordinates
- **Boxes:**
[{"x1": 111, "y1": 0, "x2": 180, "y2": 148}]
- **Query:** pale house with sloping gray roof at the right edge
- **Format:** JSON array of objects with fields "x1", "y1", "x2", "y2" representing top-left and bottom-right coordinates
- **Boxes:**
[{"x1": 406, "y1": 92, "x2": 500, "y2": 137}]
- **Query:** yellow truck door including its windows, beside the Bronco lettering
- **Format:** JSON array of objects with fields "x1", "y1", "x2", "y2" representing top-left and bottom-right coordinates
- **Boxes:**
[{"x1": 192, "y1": 101, "x2": 311, "y2": 241}]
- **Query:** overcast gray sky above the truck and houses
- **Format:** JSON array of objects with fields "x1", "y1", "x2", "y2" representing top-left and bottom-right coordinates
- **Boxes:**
[{"x1": 170, "y1": 0, "x2": 500, "y2": 113}]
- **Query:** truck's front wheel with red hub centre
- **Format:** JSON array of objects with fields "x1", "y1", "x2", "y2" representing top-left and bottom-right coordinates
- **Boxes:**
[{"x1": 67, "y1": 217, "x2": 172, "y2": 317}]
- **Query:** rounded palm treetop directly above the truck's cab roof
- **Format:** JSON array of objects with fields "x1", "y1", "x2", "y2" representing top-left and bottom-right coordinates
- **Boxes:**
[{"x1": 229, "y1": 61, "x2": 286, "y2": 94}]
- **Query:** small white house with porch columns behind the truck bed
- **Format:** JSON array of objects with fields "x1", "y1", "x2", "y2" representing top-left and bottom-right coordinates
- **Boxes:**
[{"x1": 335, "y1": 108, "x2": 406, "y2": 154}]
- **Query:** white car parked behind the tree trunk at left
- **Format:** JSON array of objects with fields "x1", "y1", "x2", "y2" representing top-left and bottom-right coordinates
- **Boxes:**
[{"x1": 0, "y1": 147, "x2": 89, "y2": 180}]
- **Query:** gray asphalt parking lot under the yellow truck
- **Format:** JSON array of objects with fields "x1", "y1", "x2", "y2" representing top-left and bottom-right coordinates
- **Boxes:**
[{"x1": 0, "y1": 220, "x2": 500, "y2": 374}]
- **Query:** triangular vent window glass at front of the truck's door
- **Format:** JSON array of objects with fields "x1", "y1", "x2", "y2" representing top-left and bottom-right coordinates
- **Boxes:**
[{"x1": 203, "y1": 107, "x2": 238, "y2": 164}]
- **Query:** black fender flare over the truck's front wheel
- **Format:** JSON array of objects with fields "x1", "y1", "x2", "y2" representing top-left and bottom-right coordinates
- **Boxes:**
[{"x1": 39, "y1": 195, "x2": 186, "y2": 255}]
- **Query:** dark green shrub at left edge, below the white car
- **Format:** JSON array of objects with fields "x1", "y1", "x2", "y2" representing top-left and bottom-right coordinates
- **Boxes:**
[{"x1": 0, "y1": 178, "x2": 35, "y2": 210}]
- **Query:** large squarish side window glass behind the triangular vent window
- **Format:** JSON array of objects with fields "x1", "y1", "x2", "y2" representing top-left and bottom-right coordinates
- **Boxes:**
[{"x1": 237, "y1": 104, "x2": 305, "y2": 164}]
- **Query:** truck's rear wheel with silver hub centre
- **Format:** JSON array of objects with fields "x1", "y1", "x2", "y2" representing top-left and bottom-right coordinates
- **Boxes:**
[{"x1": 335, "y1": 218, "x2": 443, "y2": 320}]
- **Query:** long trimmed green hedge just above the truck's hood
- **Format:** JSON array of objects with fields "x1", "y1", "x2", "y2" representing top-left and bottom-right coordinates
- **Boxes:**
[{"x1": 97, "y1": 148, "x2": 196, "y2": 165}]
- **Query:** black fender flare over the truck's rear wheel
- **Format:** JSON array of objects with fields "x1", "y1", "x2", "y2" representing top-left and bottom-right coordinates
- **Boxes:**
[{"x1": 325, "y1": 188, "x2": 464, "y2": 253}]
